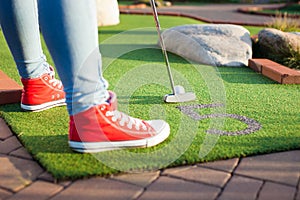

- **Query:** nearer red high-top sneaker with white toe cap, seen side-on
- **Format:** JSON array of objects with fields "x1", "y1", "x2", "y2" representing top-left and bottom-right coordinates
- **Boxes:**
[{"x1": 69, "y1": 92, "x2": 170, "y2": 153}]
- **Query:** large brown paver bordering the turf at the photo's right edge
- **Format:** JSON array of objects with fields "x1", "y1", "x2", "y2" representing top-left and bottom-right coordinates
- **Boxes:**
[{"x1": 235, "y1": 150, "x2": 300, "y2": 187}]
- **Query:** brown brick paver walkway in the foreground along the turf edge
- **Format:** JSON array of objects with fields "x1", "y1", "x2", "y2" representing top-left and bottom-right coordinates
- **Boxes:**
[{"x1": 0, "y1": 3, "x2": 300, "y2": 200}]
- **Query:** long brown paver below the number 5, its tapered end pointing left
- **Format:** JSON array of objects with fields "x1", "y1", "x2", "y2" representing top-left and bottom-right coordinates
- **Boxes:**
[{"x1": 163, "y1": 167, "x2": 231, "y2": 187}]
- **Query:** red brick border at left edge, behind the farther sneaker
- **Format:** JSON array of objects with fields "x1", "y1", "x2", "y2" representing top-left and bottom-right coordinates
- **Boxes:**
[{"x1": 0, "y1": 70, "x2": 22, "y2": 105}]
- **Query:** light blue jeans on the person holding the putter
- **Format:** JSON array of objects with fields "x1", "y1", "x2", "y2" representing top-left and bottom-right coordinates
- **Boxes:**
[{"x1": 0, "y1": 0, "x2": 108, "y2": 115}]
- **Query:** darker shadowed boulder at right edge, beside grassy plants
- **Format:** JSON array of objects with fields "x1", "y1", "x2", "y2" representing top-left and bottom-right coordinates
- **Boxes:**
[{"x1": 258, "y1": 28, "x2": 300, "y2": 60}]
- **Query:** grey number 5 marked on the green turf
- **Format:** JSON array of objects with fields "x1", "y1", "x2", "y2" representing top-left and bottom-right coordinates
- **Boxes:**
[{"x1": 177, "y1": 104, "x2": 262, "y2": 135}]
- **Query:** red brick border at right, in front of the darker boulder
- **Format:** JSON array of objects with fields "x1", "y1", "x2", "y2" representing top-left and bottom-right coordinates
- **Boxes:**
[{"x1": 248, "y1": 59, "x2": 300, "y2": 84}]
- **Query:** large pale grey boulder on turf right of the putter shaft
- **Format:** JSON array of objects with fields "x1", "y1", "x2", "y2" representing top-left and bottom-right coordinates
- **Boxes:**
[{"x1": 162, "y1": 24, "x2": 252, "y2": 67}]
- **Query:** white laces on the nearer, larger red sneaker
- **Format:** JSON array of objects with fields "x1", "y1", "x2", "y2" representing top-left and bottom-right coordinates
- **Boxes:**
[{"x1": 106, "y1": 110, "x2": 147, "y2": 131}]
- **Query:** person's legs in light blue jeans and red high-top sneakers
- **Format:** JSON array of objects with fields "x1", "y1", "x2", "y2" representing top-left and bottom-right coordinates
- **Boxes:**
[{"x1": 0, "y1": 0, "x2": 170, "y2": 152}]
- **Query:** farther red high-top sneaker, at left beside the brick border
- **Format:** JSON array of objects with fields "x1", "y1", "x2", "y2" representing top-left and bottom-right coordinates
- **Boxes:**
[{"x1": 21, "y1": 68, "x2": 66, "y2": 112}]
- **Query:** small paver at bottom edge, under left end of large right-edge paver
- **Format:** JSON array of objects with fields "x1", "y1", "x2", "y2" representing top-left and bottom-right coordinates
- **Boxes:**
[{"x1": 219, "y1": 175, "x2": 263, "y2": 200}]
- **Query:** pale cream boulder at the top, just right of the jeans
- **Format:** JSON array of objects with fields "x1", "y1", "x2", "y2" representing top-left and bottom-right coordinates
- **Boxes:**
[{"x1": 96, "y1": 0, "x2": 120, "y2": 26}]
